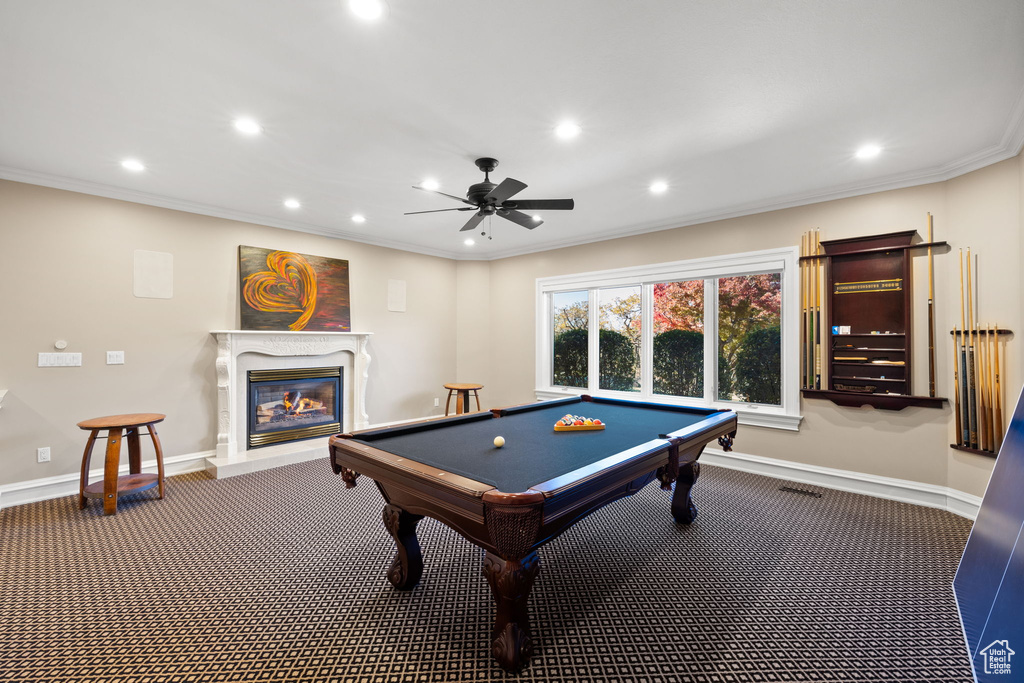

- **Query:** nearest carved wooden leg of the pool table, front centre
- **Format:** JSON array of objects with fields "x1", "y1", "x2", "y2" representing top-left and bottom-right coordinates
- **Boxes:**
[{"x1": 483, "y1": 551, "x2": 541, "y2": 672}]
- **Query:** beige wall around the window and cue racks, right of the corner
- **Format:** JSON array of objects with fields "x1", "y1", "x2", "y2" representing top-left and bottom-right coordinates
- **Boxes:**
[{"x1": 488, "y1": 153, "x2": 1024, "y2": 495}]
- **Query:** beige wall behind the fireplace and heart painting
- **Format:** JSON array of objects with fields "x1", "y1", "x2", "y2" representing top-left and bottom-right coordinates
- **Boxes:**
[{"x1": 0, "y1": 181, "x2": 457, "y2": 484}]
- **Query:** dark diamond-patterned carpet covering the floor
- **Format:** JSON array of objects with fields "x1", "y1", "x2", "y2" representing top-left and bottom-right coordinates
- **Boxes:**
[{"x1": 0, "y1": 461, "x2": 971, "y2": 683}]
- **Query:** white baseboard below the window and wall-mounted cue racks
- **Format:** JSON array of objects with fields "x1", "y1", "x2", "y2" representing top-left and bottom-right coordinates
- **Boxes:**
[{"x1": 700, "y1": 447, "x2": 981, "y2": 519}]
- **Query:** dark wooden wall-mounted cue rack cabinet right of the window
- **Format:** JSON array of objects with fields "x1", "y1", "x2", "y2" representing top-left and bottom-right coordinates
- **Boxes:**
[{"x1": 801, "y1": 230, "x2": 946, "y2": 411}]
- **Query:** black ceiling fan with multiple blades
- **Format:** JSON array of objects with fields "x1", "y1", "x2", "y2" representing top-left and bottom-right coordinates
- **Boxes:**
[{"x1": 406, "y1": 157, "x2": 574, "y2": 232}]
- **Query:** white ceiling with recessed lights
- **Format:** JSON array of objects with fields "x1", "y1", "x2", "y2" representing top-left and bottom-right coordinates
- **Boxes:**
[{"x1": 0, "y1": 0, "x2": 1024, "y2": 259}]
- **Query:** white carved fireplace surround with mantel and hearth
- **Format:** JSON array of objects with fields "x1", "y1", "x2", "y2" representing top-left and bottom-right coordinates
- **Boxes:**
[{"x1": 206, "y1": 330, "x2": 370, "y2": 478}]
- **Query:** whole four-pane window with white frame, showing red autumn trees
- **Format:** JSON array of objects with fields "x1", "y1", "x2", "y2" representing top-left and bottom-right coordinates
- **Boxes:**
[{"x1": 537, "y1": 248, "x2": 800, "y2": 429}]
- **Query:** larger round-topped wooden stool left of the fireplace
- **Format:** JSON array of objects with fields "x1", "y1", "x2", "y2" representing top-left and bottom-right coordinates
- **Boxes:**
[{"x1": 78, "y1": 413, "x2": 167, "y2": 515}]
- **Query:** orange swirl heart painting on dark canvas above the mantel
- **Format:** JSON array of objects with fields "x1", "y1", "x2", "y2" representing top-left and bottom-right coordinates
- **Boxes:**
[{"x1": 239, "y1": 246, "x2": 349, "y2": 332}]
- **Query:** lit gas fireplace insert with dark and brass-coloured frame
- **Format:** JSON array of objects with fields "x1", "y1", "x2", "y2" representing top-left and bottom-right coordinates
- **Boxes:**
[{"x1": 247, "y1": 368, "x2": 342, "y2": 449}]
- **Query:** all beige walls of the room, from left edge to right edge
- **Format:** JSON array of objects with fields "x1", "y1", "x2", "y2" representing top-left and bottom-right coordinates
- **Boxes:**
[{"x1": 0, "y1": 157, "x2": 1024, "y2": 495}]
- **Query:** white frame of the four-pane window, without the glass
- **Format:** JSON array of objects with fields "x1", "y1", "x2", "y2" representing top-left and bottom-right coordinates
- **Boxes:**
[{"x1": 536, "y1": 247, "x2": 803, "y2": 431}]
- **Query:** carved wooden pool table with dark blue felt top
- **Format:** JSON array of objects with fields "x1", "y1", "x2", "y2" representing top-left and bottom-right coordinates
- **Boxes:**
[{"x1": 330, "y1": 395, "x2": 736, "y2": 672}]
